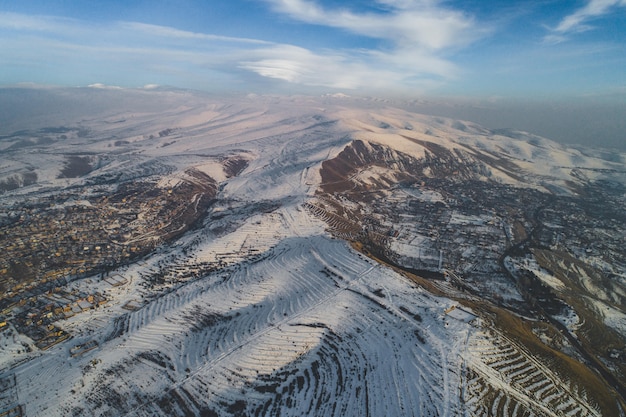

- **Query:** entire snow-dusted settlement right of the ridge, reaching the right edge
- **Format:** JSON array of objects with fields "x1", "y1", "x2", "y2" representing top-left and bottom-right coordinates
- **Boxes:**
[{"x1": 314, "y1": 166, "x2": 626, "y2": 308}]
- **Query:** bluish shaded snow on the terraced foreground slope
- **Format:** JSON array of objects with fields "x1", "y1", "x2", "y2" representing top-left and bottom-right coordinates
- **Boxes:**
[{"x1": 7, "y1": 229, "x2": 469, "y2": 416}]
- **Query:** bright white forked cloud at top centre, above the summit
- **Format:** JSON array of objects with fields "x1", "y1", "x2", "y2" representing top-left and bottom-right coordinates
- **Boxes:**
[{"x1": 236, "y1": 0, "x2": 489, "y2": 89}]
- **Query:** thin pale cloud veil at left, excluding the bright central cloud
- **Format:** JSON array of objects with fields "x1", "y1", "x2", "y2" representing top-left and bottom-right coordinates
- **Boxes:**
[{"x1": 0, "y1": 12, "x2": 273, "y2": 88}]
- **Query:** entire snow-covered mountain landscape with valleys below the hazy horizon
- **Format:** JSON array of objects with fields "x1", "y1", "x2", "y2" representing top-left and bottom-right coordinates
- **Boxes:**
[{"x1": 0, "y1": 89, "x2": 626, "y2": 416}]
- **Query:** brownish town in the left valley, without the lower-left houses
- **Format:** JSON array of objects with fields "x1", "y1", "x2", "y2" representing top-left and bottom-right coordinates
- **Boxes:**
[{"x1": 0, "y1": 174, "x2": 211, "y2": 298}]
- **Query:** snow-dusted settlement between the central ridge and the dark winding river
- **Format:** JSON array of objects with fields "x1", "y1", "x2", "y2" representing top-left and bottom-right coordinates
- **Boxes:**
[{"x1": 306, "y1": 179, "x2": 540, "y2": 274}]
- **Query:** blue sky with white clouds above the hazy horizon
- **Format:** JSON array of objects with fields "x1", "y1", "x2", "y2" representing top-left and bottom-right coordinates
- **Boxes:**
[{"x1": 0, "y1": 0, "x2": 626, "y2": 98}]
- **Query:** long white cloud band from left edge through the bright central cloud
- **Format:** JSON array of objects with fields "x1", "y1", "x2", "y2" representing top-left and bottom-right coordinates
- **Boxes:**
[{"x1": 0, "y1": 0, "x2": 484, "y2": 91}]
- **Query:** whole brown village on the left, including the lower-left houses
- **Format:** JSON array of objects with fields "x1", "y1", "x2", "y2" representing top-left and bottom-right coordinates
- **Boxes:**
[{"x1": 0, "y1": 171, "x2": 217, "y2": 356}]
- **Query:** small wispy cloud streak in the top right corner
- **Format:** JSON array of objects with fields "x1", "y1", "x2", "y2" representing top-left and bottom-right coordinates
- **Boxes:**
[{"x1": 544, "y1": 0, "x2": 626, "y2": 43}]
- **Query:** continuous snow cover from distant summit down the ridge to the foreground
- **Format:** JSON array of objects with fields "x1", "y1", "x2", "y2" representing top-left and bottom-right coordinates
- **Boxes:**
[{"x1": 0, "y1": 93, "x2": 620, "y2": 417}]
